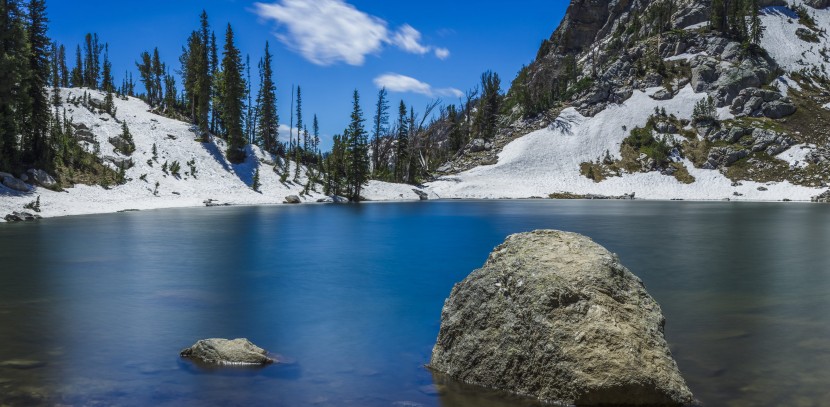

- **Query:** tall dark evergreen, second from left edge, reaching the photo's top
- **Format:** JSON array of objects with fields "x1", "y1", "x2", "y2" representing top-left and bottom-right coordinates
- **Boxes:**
[{"x1": 23, "y1": 0, "x2": 52, "y2": 167}]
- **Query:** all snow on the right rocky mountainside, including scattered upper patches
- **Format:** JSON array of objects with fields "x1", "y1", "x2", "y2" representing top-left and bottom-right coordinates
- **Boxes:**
[{"x1": 429, "y1": 1, "x2": 830, "y2": 201}]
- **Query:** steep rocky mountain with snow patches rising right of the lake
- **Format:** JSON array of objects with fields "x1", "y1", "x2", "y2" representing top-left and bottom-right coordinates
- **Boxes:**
[{"x1": 432, "y1": 0, "x2": 830, "y2": 200}]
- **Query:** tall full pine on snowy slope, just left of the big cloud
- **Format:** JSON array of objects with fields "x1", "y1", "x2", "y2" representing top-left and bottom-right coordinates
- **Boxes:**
[{"x1": 220, "y1": 24, "x2": 245, "y2": 163}]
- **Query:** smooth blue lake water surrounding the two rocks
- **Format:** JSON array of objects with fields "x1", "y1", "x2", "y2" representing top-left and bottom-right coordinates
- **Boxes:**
[{"x1": 0, "y1": 201, "x2": 830, "y2": 407}]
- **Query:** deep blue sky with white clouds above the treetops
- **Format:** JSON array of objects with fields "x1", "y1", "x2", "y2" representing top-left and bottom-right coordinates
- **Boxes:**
[{"x1": 47, "y1": 0, "x2": 568, "y2": 148}]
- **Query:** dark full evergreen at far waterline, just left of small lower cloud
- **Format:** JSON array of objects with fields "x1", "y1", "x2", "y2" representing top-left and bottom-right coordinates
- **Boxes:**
[{"x1": 344, "y1": 90, "x2": 369, "y2": 202}]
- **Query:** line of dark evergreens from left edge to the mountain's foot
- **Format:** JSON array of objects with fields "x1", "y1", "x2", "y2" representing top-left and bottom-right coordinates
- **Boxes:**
[{"x1": 0, "y1": 0, "x2": 505, "y2": 200}]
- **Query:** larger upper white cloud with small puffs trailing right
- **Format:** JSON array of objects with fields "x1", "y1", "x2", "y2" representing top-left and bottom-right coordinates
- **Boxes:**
[{"x1": 253, "y1": 0, "x2": 450, "y2": 66}]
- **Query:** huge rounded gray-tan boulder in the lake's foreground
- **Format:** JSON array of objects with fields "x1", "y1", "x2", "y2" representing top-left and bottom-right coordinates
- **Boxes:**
[{"x1": 429, "y1": 230, "x2": 693, "y2": 406}]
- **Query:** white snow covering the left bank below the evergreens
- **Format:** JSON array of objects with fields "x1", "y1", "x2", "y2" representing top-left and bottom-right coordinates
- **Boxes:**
[{"x1": 0, "y1": 89, "x2": 419, "y2": 222}]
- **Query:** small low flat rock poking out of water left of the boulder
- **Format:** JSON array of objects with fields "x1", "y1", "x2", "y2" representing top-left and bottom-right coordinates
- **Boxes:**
[{"x1": 180, "y1": 338, "x2": 274, "y2": 365}]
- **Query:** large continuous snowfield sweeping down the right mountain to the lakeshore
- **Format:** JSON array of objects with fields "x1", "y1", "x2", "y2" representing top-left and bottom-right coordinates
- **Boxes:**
[{"x1": 429, "y1": 86, "x2": 820, "y2": 200}]
